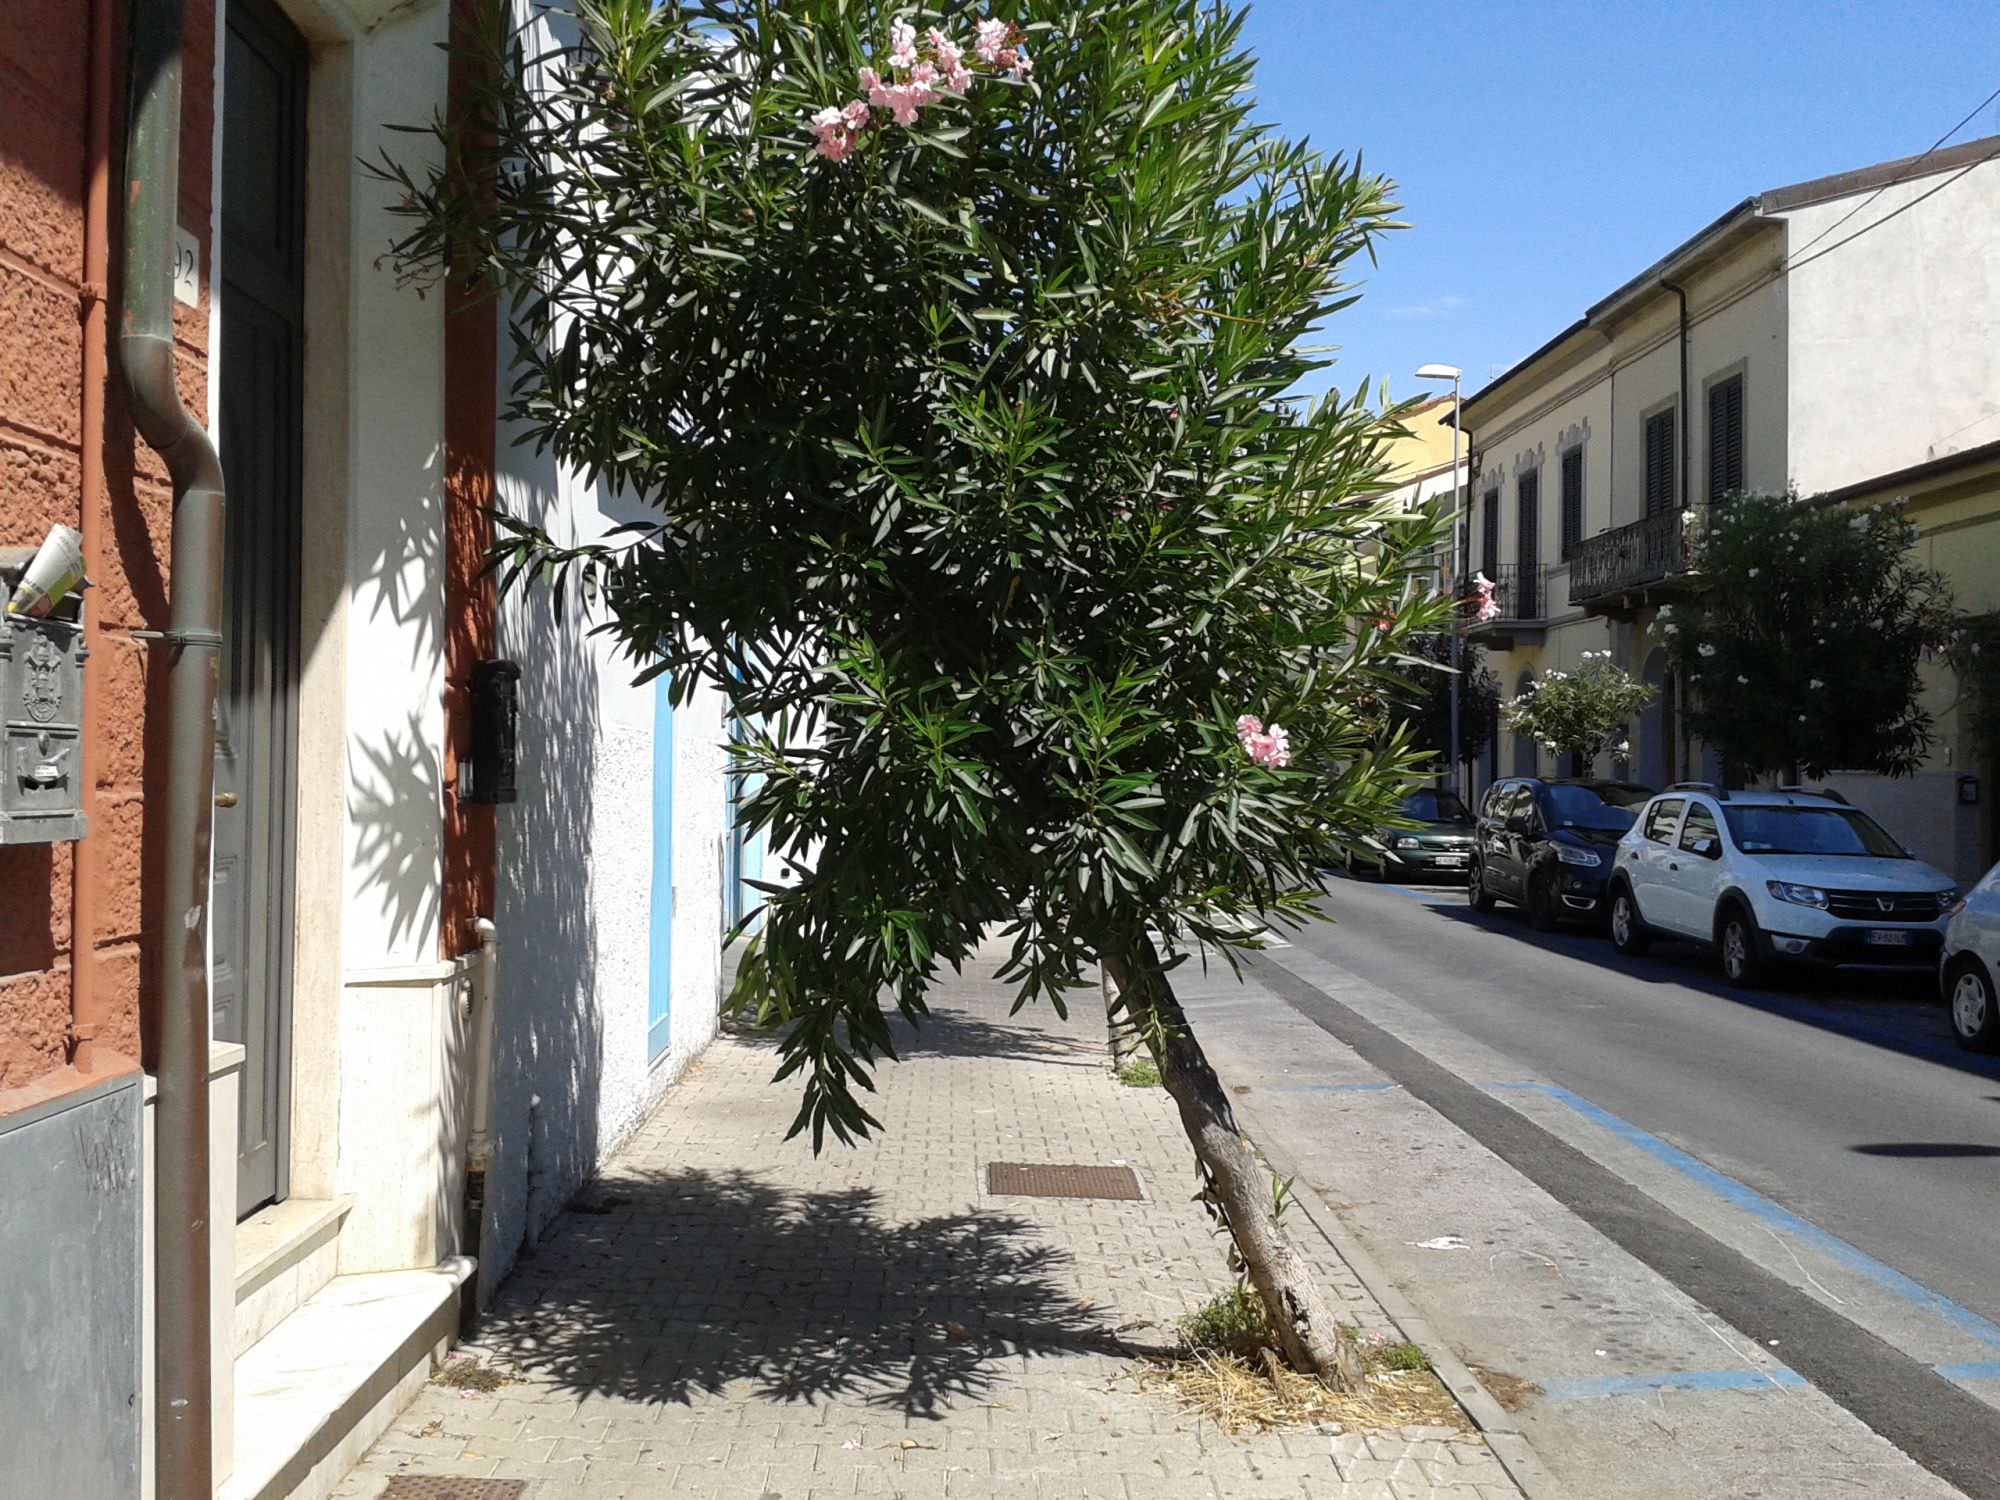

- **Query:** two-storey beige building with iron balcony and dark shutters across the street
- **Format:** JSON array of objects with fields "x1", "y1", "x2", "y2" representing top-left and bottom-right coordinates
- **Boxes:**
[{"x1": 1464, "y1": 136, "x2": 2000, "y2": 872}]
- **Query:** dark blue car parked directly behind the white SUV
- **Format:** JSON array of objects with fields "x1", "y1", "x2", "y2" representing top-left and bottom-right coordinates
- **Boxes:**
[{"x1": 1466, "y1": 776, "x2": 1652, "y2": 932}]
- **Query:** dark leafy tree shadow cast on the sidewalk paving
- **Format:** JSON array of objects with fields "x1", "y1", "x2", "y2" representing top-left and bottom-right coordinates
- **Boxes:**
[{"x1": 478, "y1": 1170, "x2": 1142, "y2": 1418}]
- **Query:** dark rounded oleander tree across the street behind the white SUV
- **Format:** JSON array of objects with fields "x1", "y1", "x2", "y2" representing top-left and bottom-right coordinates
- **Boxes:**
[{"x1": 1660, "y1": 494, "x2": 1954, "y2": 778}]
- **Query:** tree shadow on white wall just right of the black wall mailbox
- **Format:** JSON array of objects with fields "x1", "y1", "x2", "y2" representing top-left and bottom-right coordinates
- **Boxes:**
[{"x1": 480, "y1": 590, "x2": 604, "y2": 1286}]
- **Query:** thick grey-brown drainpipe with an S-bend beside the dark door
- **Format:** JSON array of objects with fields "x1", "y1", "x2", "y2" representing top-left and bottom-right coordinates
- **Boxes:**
[{"x1": 118, "y1": 0, "x2": 222, "y2": 1500}]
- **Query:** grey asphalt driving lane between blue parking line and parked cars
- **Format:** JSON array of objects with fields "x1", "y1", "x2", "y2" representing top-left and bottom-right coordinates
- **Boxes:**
[{"x1": 1292, "y1": 882, "x2": 2000, "y2": 1344}]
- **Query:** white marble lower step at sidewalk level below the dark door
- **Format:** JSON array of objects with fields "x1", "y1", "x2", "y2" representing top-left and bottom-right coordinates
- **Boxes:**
[{"x1": 216, "y1": 1256, "x2": 474, "y2": 1500}]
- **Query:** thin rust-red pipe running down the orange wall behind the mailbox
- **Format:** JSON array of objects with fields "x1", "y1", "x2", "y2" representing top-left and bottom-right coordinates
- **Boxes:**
[{"x1": 70, "y1": 0, "x2": 114, "y2": 1074}]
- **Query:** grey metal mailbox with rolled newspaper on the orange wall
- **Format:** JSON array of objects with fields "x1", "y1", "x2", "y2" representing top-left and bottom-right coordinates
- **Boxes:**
[{"x1": 0, "y1": 548, "x2": 88, "y2": 844}]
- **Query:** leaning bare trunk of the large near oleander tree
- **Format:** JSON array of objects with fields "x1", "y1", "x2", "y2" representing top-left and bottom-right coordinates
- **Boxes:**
[{"x1": 1104, "y1": 938, "x2": 1366, "y2": 1390}]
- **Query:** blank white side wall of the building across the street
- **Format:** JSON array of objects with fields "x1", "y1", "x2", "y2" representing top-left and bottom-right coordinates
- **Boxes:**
[{"x1": 1786, "y1": 158, "x2": 2000, "y2": 494}]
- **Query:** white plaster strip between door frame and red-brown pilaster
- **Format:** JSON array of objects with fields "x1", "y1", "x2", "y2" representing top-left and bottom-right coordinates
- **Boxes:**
[{"x1": 334, "y1": 4, "x2": 446, "y2": 972}]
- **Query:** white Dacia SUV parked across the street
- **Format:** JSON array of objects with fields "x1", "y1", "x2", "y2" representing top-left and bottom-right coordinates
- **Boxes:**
[{"x1": 1610, "y1": 782, "x2": 1958, "y2": 988}]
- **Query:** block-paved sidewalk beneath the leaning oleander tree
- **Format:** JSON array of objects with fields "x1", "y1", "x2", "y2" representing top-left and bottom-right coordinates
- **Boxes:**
[{"x1": 338, "y1": 950, "x2": 1518, "y2": 1500}]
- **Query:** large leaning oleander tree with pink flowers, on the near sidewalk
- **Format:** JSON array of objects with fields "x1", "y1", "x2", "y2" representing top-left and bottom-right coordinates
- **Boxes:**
[{"x1": 378, "y1": 0, "x2": 1448, "y2": 1386}]
